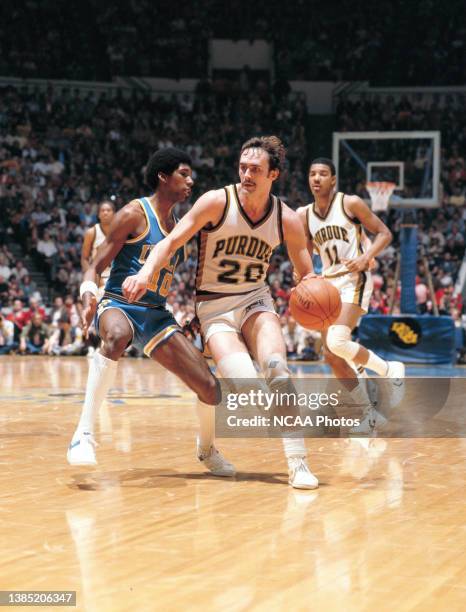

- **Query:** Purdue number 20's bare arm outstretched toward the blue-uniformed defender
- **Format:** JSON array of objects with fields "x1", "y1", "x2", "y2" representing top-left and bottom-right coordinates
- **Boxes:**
[{"x1": 123, "y1": 189, "x2": 225, "y2": 302}]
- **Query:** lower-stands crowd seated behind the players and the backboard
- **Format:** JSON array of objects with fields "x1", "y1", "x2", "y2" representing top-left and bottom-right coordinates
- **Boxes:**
[{"x1": 0, "y1": 81, "x2": 466, "y2": 358}]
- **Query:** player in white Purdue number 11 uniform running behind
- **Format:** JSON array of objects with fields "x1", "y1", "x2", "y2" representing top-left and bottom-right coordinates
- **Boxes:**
[{"x1": 297, "y1": 157, "x2": 405, "y2": 434}]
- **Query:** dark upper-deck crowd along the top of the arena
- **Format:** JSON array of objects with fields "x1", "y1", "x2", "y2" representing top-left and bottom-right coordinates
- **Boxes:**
[{"x1": 0, "y1": 0, "x2": 466, "y2": 85}]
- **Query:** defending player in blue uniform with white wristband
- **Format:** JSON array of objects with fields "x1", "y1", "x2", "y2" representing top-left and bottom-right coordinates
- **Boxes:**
[{"x1": 67, "y1": 148, "x2": 235, "y2": 476}]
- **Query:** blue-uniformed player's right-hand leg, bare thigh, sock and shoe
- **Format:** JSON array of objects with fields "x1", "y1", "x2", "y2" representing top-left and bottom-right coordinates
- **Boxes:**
[{"x1": 151, "y1": 333, "x2": 236, "y2": 476}]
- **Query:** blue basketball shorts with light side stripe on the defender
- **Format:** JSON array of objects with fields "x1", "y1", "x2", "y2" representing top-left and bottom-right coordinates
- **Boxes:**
[{"x1": 95, "y1": 297, "x2": 181, "y2": 357}]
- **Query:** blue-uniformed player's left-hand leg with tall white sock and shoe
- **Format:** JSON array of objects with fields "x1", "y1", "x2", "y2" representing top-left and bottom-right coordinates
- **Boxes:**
[{"x1": 67, "y1": 307, "x2": 133, "y2": 465}]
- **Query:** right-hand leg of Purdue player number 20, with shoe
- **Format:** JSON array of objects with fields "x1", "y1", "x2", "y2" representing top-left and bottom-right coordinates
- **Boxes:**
[{"x1": 241, "y1": 311, "x2": 319, "y2": 489}]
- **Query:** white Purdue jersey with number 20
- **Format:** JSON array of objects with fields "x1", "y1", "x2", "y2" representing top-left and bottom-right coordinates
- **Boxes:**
[{"x1": 196, "y1": 185, "x2": 283, "y2": 299}]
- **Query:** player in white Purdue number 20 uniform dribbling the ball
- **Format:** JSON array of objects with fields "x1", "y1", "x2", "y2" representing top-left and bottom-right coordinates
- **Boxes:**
[{"x1": 123, "y1": 136, "x2": 318, "y2": 489}]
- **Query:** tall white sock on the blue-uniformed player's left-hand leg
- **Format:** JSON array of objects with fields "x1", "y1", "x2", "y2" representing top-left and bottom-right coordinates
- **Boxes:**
[{"x1": 77, "y1": 352, "x2": 118, "y2": 433}]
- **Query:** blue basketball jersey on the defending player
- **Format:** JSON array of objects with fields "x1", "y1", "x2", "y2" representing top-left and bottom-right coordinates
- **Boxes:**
[{"x1": 105, "y1": 198, "x2": 184, "y2": 308}]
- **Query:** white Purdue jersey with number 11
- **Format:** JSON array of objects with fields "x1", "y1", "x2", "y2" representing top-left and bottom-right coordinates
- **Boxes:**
[{"x1": 306, "y1": 192, "x2": 363, "y2": 277}]
